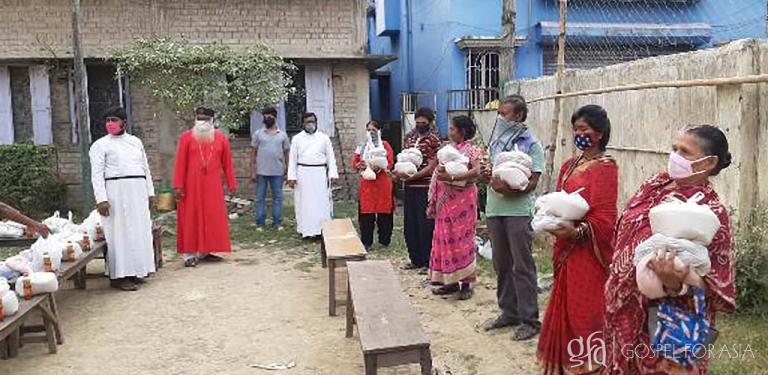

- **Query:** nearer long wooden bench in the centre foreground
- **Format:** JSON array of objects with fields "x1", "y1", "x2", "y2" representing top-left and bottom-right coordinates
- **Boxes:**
[{"x1": 346, "y1": 261, "x2": 432, "y2": 375}]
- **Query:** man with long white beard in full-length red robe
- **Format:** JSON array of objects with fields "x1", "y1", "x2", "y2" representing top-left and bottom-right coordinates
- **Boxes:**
[{"x1": 173, "y1": 107, "x2": 237, "y2": 267}]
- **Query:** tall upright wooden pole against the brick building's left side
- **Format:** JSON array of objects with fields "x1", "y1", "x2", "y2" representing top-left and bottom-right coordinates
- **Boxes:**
[{"x1": 69, "y1": 0, "x2": 94, "y2": 215}]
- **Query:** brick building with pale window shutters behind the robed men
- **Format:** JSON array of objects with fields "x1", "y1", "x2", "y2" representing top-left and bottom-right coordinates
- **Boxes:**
[{"x1": 0, "y1": 0, "x2": 389, "y2": 203}]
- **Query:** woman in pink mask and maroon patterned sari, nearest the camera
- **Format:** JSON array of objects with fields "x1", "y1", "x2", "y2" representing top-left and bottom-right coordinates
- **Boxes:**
[{"x1": 602, "y1": 125, "x2": 736, "y2": 375}]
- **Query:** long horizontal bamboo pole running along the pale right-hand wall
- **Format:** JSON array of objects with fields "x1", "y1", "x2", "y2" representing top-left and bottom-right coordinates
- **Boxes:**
[{"x1": 528, "y1": 74, "x2": 768, "y2": 103}]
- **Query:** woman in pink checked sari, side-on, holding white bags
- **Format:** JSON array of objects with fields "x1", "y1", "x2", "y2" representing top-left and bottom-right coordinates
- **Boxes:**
[{"x1": 427, "y1": 116, "x2": 480, "y2": 300}]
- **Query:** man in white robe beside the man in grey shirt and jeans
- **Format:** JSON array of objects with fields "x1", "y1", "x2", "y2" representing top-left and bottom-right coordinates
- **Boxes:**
[{"x1": 288, "y1": 112, "x2": 339, "y2": 238}]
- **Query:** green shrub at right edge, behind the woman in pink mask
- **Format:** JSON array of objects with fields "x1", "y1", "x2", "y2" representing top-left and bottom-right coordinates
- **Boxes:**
[{"x1": 736, "y1": 205, "x2": 768, "y2": 314}]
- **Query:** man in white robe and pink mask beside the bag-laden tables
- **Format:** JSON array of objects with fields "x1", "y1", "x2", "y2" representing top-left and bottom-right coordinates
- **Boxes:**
[{"x1": 89, "y1": 108, "x2": 155, "y2": 291}]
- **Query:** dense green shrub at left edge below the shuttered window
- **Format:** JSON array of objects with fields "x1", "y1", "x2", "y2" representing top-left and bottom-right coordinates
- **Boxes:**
[{"x1": 0, "y1": 145, "x2": 66, "y2": 219}]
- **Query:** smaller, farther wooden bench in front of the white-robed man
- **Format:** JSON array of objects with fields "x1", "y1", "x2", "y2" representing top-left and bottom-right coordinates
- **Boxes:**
[{"x1": 320, "y1": 218, "x2": 368, "y2": 316}]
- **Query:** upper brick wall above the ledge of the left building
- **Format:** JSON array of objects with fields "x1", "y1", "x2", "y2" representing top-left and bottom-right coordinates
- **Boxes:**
[{"x1": 0, "y1": 0, "x2": 366, "y2": 59}]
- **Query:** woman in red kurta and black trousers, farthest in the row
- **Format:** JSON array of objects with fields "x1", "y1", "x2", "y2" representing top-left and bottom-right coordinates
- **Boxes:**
[{"x1": 352, "y1": 121, "x2": 395, "y2": 249}]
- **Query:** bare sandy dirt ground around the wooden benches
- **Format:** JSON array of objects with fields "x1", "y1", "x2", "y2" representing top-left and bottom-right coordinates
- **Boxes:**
[{"x1": 0, "y1": 244, "x2": 537, "y2": 375}]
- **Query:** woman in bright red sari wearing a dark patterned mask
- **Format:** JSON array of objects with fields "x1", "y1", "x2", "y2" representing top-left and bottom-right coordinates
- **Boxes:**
[{"x1": 538, "y1": 105, "x2": 618, "y2": 374}]
